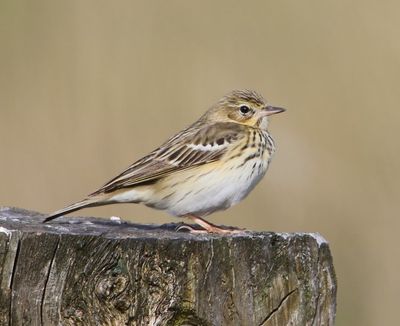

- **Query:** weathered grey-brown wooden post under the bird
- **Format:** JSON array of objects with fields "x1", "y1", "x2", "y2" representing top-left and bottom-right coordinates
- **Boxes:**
[{"x1": 0, "y1": 208, "x2": 336, "y2": 325}]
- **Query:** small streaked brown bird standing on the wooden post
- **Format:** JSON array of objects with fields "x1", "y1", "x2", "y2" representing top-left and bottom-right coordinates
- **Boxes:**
[{"x1": 43, "y1": 89, "x2": 285, "y2": 234}]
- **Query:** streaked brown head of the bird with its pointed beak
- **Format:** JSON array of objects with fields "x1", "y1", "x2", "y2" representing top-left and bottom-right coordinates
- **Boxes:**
[{"x1": 203, "y1": 90, "x2": 285, "y2": 129}]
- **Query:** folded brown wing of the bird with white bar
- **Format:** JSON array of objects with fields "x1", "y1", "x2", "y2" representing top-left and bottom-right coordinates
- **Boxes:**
[{"x1": 92, "y1": 122, "x2": 246, "y2": 195}]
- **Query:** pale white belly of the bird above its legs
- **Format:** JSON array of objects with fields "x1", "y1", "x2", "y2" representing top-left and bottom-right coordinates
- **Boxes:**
[{"x1": 145, "y1": 158, "x2": 268, "y2": 216}]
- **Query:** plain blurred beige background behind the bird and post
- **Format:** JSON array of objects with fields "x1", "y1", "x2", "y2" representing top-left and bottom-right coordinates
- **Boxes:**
[{"x1": 0, "y1": 0, "x2": 400, "y2": 326}]
